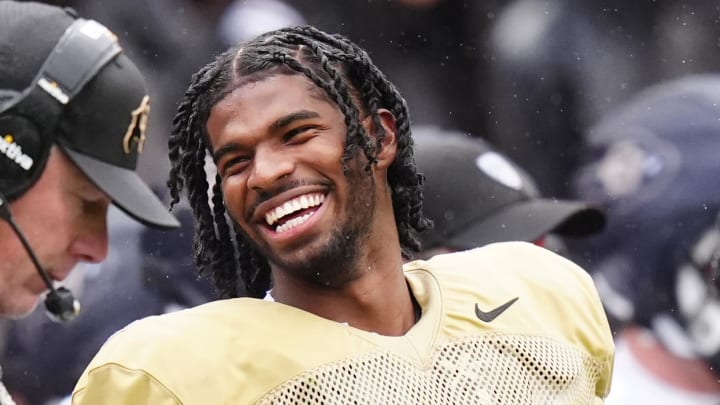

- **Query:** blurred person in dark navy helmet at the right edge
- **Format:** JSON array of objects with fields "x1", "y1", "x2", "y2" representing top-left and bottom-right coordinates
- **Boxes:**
[{"x1": 568, "y1": 74, "x2": 720, "y2": 405}]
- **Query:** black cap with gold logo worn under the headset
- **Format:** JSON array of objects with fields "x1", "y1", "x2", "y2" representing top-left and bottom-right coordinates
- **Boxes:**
[{"x1": 0, "y1": 1, "x2": 179, "y2": 228}]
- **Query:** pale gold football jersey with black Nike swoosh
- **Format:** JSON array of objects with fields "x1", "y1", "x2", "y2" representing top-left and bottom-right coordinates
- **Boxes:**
[{"x1": 73, "y1": 242, "x2": 614, "y2": 405}]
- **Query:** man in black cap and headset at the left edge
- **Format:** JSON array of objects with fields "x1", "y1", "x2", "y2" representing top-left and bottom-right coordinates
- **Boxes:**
[{"x1": 0, "y1": 1, "x2": 178, "y2": 320}]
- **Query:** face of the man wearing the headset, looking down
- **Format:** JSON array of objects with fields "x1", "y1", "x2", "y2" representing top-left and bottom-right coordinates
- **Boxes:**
[{"x1": 0, "y1": 148, "x2": 110, "y2": 318}]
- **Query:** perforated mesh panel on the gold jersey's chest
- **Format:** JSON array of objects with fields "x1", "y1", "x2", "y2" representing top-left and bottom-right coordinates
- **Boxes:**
[{"x1": 258, "y1": 334, "x2": 602, "y2": 405}]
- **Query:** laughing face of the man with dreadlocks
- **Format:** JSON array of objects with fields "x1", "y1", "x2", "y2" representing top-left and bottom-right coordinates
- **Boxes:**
[{"x1": 207, "y1": 75, "x2": 375, "y2": 285}]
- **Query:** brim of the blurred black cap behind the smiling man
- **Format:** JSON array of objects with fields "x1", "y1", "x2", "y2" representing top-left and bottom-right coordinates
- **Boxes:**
[{"x1": 447, "y1": 199, "x2": 605, "y2": 249}]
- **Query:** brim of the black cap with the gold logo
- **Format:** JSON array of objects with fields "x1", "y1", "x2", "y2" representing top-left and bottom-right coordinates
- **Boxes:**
[{"x1": 63, "y1": 148, "x2": 180, "y2": 228}]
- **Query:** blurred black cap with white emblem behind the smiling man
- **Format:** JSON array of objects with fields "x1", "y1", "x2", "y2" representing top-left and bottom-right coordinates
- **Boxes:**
[{"x1": 413, "y1": 127, "x2": 605, "y2": 249}]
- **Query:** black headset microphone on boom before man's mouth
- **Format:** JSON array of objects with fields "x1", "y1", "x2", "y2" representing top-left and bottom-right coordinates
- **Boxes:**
[{"x1": 0, "y1": 193, "x2": 80, "y2": 322}]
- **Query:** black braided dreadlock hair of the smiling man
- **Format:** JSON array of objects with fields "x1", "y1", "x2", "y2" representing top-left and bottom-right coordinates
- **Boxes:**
[{"x1": 168, "y1": 26, "x2": 431, "y2": 298}]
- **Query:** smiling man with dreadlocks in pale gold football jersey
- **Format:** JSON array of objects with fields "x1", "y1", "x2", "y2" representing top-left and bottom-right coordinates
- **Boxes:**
[{"x1": 73, "y1": 27, "x2": 613, "y2": 404}]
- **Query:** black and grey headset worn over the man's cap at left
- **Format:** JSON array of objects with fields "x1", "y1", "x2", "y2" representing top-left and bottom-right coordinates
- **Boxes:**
[{"x1": 0, "y1": 13, "x2": 122, "y2": 322}]
